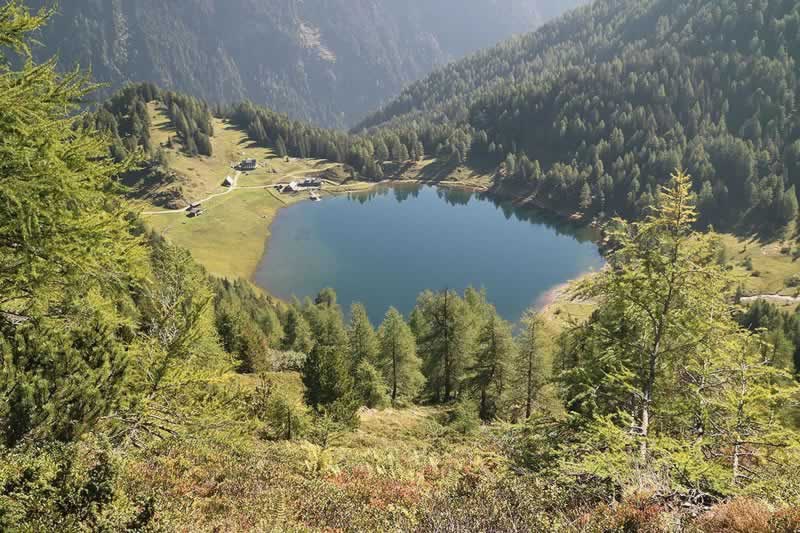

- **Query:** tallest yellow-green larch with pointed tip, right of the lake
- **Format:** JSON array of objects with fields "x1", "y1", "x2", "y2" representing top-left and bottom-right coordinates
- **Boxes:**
[{"x1": 561, "y1": 171, "x2": 729, "y2": 464}]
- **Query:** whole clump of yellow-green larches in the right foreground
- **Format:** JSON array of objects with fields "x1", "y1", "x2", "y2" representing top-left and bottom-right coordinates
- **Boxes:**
[{"x1": 558, "y1": 171, "x2": 798, "y2": 494}]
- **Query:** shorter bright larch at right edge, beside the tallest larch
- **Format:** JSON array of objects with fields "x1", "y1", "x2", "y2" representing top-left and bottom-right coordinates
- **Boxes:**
[{"x1": 681, "y1": 330, "x2": 800, "y2": 494}]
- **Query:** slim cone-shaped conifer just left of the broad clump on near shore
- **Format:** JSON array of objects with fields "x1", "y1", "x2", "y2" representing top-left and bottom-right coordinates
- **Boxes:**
[{"x1": 378, "y1": 307, "x2": 425, "y2": 405}]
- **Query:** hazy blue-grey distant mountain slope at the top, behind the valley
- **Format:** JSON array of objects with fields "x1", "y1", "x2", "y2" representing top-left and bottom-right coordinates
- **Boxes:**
[{"x1": 29, "y1": 0, "x2": 584, "y2": 126}]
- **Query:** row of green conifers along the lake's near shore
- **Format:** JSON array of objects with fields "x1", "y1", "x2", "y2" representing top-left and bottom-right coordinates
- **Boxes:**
[{"x1": 284, "y1": 289, "x2": 544, "y2": 420}]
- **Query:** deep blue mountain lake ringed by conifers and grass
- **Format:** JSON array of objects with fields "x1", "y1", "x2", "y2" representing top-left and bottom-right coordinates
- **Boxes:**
[{"x1": 254, "y1": 184, "x2": 603, "y2": 325}]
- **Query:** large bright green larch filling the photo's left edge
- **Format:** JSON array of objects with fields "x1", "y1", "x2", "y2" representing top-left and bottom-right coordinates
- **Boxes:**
[{"x1": 0, "y1": 0, "x2": 146, "y2": 446}]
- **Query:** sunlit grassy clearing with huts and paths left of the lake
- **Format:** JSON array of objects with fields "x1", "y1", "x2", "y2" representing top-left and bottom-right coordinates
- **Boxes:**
[{"x1": 144, "y1": 103, "x2": 370, "y2": 279}]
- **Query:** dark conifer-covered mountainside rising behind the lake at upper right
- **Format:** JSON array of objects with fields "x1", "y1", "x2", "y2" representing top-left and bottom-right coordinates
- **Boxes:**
[{"x1": 362, "y1": 0, "x2": 800, "y2": 233}]
